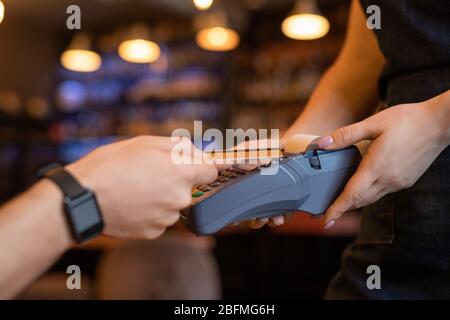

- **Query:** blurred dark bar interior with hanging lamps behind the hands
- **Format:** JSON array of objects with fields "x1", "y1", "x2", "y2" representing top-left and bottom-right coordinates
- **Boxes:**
[{"x1": 0, "y1": 0, "x2": 358, "y2": 299}]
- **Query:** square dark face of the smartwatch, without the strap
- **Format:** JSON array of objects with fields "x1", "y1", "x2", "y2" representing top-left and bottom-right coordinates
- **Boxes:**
[{"x1": 65, "y1": 192, "x2": 103, "y2": 242}]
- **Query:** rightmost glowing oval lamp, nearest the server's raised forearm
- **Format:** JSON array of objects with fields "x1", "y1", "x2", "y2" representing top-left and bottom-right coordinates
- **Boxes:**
[{"x1": 281, "y1": 13, "x2": 330, "y2": 40}]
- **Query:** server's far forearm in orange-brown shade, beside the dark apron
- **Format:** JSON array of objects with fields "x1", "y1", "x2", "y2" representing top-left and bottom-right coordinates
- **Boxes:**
[{"x1": 284, "y1": 1, "x2": 385, "y2": 138}]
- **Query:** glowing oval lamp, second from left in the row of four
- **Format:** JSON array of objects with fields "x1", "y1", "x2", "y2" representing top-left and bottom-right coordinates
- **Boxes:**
[{"x1": 119, "y1": 39, "x2": 161, "y2": 63}]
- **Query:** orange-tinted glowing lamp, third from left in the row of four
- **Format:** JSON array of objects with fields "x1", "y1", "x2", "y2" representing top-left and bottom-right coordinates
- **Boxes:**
[{"x1": 195, "y1": 27, "x2": 239, "y2": 51}]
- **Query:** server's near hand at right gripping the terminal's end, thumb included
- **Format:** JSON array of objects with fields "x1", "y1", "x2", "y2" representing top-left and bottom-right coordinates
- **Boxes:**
[{"x1": 318, "y1": 91, "x2": 450, "y2": 228}]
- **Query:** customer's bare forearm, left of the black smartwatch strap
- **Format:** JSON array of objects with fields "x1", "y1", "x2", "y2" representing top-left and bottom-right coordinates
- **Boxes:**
[{"x1": 0, "y1": 180, "x2": 72, "y2": 298}]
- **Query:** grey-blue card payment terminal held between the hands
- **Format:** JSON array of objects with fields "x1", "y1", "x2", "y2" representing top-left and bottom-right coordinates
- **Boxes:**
[{"x1": 181, "y1": 134, "x2": 361, "y2": 235}]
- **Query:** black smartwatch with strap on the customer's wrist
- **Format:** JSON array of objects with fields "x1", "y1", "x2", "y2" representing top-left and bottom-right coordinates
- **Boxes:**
[{"x1": 38, "y1": 163, "x2": 103, "y2": 243}]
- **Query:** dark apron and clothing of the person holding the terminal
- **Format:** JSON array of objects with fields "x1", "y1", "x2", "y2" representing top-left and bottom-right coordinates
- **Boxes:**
[{"x1": 325, "y1": 0, "x2": 450, "y2": 299}]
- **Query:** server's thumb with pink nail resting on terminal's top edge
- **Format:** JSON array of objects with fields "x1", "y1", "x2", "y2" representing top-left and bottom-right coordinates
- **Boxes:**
[{"x1": 317, "y1": 120, "x2": 376, "y2": 150}]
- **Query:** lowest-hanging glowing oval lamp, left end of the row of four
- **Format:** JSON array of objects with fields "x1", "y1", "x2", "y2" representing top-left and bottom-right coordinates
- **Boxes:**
[{"x1": 61, "y1": 50, "x2": 102, "y2": 72}]
